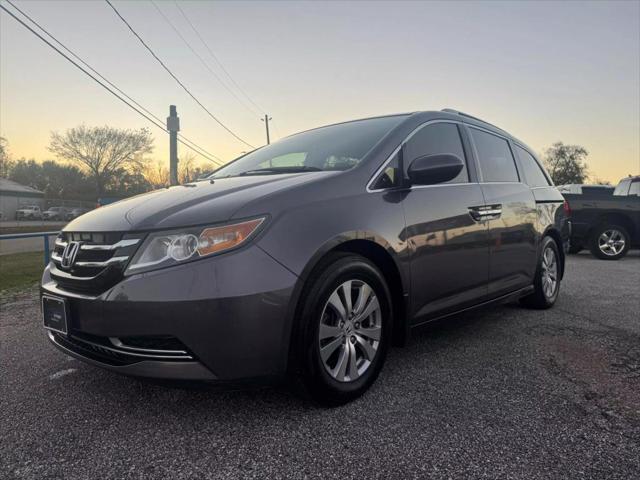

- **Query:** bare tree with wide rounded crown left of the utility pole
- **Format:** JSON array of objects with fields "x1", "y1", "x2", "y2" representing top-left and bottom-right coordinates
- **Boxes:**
[{"x1": 49, "y1": 125, "x2": 153, "y2": 197}]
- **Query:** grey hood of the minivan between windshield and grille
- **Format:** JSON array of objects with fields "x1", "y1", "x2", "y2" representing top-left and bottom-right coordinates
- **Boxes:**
[{"x1": 64, "y1": 172, "x2": 336, "y2": 232}]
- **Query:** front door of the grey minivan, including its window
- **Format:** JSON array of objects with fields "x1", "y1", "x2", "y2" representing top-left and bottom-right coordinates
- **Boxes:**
[{"x1": 403, "y1": 122, "x2": 489, "y2": 323}]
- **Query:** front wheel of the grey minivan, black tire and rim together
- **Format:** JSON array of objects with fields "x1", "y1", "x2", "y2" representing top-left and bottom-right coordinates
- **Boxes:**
[{"x1": 289, "y1": 253, "x2": 393, "y2": 406}]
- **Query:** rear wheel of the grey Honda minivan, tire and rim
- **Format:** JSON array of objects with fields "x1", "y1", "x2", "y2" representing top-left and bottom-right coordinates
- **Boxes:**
[{"x1": 520, "y1": 237, "x2": 560, "y2": 310}]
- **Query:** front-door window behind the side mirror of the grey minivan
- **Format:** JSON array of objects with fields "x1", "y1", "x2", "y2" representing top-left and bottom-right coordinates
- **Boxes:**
[{"x1": 403, "y1": 123, "x2": 469, "y2": 183}]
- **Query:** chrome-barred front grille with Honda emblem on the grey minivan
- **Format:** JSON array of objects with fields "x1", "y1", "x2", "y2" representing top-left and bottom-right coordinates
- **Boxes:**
[{"x1": 50, "y1": 232, "x2": 143, "y2": 294}]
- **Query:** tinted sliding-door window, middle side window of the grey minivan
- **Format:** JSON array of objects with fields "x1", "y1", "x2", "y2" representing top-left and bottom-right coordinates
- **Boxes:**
[{"x1": 470, "y1": 128, "x2": 519, "y2": 182}]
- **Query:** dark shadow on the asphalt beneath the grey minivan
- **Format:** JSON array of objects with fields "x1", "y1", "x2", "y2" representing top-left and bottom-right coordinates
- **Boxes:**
[{"x1": 69, "y1": 296, "x2": 519, "y2": 416}]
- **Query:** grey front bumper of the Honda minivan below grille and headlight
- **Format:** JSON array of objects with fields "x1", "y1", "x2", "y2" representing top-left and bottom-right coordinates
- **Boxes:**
[{"x1": 41, "y1": 245, "x2": 298, "y2": 381}]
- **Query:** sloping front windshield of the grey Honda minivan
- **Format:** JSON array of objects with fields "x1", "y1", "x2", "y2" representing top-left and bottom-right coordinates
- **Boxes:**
[{"x1": 209, "y1": 115, "x2": 404, "y2": 178}]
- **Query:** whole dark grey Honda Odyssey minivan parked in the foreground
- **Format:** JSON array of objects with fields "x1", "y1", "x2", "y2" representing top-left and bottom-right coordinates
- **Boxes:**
[{"x1": 42, "y1": 110, "x2": 568, "y2": 404}]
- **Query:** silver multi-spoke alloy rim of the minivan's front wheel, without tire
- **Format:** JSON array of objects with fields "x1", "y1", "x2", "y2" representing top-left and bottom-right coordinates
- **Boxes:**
[{"x1": 318, "y1": 280, "x2": 382, "y2": 382}]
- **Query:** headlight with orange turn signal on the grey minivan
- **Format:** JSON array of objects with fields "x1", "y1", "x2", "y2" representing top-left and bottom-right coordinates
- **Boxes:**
[{"x1": 126, "y1": 217, "x2": 265, "y2": 274}]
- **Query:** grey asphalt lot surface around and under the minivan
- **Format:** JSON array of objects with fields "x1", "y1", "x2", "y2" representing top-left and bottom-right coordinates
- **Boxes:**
[{"x1": 0, "y1": 252, "x2": 640, "y2": 479}]
